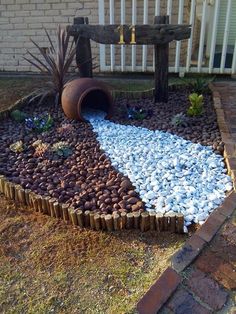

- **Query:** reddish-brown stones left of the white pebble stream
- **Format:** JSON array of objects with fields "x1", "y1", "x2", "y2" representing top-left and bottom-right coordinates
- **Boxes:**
[{"x1": 0, "y1": 99, "x2": 142, "y2": 213}]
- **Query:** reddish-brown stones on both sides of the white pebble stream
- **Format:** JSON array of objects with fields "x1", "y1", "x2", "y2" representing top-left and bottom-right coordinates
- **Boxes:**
[{"x1": 0, "y1": 89, "x2": 223, "y2": 213}]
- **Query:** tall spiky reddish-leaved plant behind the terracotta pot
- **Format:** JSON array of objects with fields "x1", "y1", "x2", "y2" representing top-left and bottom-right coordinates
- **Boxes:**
[{"x1": 24, "y1": 25, "x2": 76, "y2": 104}]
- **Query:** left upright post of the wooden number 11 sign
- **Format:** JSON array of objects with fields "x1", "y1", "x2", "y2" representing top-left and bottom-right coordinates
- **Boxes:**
[{"x1": 74, "y1": 17, "x2": 93, "y2": 77}]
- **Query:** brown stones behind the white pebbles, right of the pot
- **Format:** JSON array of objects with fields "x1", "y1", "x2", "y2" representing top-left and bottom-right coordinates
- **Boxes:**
[{"x1": 112, "y1": 87, "x2": 224, "y2": 154}]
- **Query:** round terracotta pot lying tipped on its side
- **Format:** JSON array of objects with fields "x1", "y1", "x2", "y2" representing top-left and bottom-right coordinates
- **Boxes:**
[{"x1": 61, "y1": 78, "x2": 113, "y2": 121}]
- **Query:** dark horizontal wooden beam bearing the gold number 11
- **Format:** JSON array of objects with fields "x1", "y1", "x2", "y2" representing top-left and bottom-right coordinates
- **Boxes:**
[{"x1": 67, "y1": 24, "x2": 191, "y2": 45}]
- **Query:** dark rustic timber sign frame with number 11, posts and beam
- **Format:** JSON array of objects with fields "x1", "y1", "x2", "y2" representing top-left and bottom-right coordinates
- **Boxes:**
[{"x1": 67, "y1": 16, "x2": 191, "y2": 102}]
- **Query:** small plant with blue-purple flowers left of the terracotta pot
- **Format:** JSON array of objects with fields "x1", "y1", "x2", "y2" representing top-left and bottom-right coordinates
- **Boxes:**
[{"x1": 25, "y1": 114, "x2": 53, "y2": 133}]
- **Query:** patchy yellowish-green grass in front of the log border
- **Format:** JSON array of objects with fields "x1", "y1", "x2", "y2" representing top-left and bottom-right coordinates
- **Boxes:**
[{"x1": 0, "y1": 198, "x2": 185, "y2": 314}]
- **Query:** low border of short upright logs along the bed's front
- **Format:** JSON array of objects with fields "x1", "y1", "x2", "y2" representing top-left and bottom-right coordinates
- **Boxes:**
[{"x1": 0, "y1": 175, "x2": 184, "y2": 233}]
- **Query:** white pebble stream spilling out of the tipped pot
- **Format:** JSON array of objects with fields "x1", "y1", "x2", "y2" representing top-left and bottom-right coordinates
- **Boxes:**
[{"x1": 86, "y1": 111, "x2": 232, "y2": 226}]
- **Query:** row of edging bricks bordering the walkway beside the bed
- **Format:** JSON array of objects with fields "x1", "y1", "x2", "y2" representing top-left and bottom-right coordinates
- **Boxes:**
[{"x1": 137, "y1": 83, "x2": 236, "y2": 314}]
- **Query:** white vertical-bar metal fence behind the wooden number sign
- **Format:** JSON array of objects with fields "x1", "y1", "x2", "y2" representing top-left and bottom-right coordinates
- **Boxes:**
[{"x1": 98, "y1": 0, "x2": 236, "y2": 74}]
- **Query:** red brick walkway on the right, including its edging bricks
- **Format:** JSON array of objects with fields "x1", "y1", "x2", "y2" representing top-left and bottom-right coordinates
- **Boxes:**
[{"x1": 137, "y1": 82, "x2": 236, "y2": 314}]
